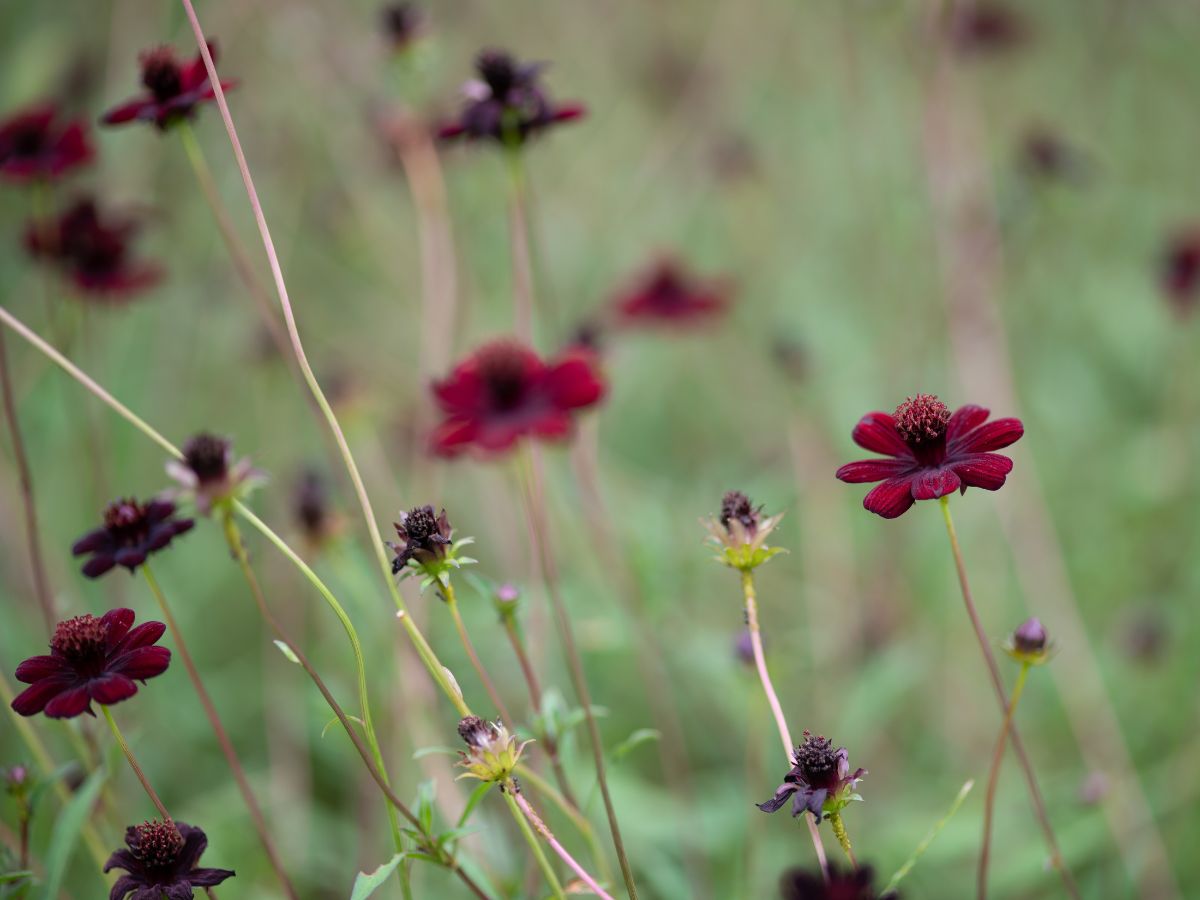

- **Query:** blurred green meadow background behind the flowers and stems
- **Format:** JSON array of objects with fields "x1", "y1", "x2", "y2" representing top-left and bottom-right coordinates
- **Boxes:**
[{"x1": 0, "y1": 0, "x2": 1200, "y2": 900}]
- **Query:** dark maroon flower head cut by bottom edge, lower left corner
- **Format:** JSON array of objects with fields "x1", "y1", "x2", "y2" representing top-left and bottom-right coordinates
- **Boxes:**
[{"x1": 104, "y1": 820, "x2": 234, "y2": 900}]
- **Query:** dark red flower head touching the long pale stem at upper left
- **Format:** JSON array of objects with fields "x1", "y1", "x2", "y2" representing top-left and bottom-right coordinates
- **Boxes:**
[{"x1": 100, "y1": 41, "x2": 238, "y2": 131}]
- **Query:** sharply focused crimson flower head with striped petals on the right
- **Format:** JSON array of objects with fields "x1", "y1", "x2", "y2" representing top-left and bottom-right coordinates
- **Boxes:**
[{"x1": 838, "y1": 394, "x2": 1025, "y2": 518}]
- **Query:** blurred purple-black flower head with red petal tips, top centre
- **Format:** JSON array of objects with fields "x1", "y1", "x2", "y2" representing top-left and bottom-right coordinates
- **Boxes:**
[{"x1": 438, "y1": 50, "x2": 584, "y2": 146}]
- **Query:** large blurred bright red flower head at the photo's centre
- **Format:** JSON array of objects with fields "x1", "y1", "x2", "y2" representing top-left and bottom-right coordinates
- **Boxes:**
[{"x1": 431, "y1": 341, "x2": 605, "y2": 456}]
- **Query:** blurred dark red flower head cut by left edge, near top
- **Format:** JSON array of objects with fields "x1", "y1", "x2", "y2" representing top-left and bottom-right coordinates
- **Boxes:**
[{"x1": 0, "y1": 103, "x2": 95, "y2": 181}]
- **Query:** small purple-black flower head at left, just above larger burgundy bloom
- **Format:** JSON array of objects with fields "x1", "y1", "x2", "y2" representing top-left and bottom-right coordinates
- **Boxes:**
[{"x1": 71, "y1": 498, "x2": 196, "y2": 578}]
